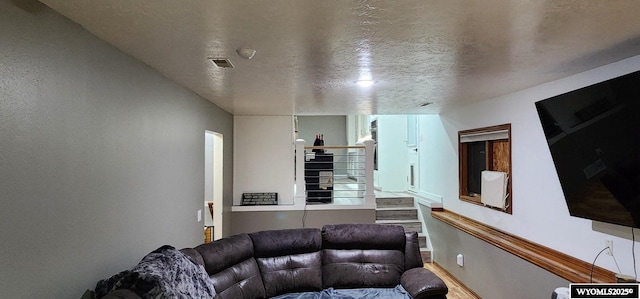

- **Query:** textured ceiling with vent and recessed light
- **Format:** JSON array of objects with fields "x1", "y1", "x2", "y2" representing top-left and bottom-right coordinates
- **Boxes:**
[{"x1": 41, "y1": 0, "x2": 640, "y2": 115}]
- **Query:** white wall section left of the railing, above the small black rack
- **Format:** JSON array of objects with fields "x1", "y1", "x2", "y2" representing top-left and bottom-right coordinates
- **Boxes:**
[{"x1": 233, "y1": 116, "x2": 296, "y2": 205}]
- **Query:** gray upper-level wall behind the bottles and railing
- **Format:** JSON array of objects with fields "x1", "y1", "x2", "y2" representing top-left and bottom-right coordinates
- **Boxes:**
[{"x1": 297, "y1": 115, "x2": 348, "y2": 175}]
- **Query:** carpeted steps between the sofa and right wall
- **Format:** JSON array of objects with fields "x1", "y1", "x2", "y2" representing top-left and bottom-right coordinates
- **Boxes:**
[{"x1": 376, "y1": 197, "x2": 432, "y2": 263}]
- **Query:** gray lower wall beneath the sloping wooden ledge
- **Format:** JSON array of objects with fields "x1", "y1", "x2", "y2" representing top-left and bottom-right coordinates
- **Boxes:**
[{"x1": 420, "y1": 205, "x2": 569, "y2": 299}]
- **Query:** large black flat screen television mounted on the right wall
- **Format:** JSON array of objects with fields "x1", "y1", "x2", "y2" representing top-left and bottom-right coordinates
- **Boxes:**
[{"x1": 536, "y1": 71, "x2": 640, "y2": 228}]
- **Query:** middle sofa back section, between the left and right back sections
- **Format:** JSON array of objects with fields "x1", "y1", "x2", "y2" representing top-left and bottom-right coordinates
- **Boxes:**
[{"x1": 249, "y1": 228, "x2": 322, "y2": 297}]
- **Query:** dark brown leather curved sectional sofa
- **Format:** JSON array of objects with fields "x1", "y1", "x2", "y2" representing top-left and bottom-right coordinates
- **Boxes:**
[{"x1": 103, "y1": 224, "x2": 448, "y2": 299}]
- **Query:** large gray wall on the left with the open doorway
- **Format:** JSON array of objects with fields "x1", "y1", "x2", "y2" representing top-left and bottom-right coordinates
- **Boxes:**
[{"x1": 0, "y1": 0, "x2": 233, "y2": 298}]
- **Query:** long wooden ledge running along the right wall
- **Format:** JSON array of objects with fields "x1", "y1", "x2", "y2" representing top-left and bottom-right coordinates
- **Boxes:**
[{"x1": 431, "y1": 209, "x2": 616, "y2": 283}]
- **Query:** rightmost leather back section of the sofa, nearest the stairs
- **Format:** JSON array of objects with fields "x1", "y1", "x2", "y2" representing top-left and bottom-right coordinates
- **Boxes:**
[{"x1": 322, "y1": 224, "x2": 406, "y2": 288}]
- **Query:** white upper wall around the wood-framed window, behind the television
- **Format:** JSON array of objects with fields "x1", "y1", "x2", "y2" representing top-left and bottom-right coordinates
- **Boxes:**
[{"x1": 420, "y1": 56, "x2": 640, "y2": 275}]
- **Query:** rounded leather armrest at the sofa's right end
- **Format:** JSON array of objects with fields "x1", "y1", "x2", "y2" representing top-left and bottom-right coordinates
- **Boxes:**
[{"x1": 400, "y1": 268, "x2": 449, "y2": 299}]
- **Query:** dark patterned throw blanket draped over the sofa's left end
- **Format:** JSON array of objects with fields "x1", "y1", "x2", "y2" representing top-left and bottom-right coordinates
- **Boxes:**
[{"x1": 95, "y1": 245, "x2": 216, "y2": 299}]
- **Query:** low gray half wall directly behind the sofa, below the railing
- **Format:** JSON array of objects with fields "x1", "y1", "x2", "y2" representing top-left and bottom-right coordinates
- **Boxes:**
[{"x1": 231, "y1": 210, "x2": 376, "y2": 234}]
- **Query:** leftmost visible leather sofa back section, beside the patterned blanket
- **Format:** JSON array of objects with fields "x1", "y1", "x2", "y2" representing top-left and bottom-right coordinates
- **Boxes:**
[{"x1": 194, "y1": 234, "x2": 266, "y2": 299}]
